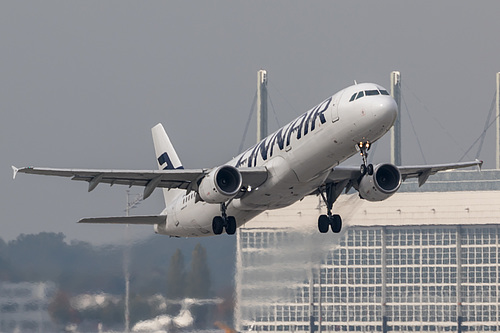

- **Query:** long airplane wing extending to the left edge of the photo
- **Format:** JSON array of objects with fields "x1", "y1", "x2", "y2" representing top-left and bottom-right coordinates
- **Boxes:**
[{"x1": 12, "y1": 166, "x2": 267, "y2": 198}]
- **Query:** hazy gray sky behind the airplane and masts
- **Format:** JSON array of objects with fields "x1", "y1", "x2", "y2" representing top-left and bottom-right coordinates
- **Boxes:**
[{"x1": 0, "y1": 1, "x2": 500, "y2": 243}]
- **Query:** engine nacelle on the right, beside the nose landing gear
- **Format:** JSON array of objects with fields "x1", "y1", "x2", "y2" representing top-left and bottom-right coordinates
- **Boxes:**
[{"x1": 358, "y1": 164, "x2": 401, "y2": 201}]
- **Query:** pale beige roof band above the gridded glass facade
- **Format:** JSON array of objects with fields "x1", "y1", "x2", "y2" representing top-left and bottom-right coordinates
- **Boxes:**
[{"x1": 244, "y1": 170, "x2": 500, "y2": 229}]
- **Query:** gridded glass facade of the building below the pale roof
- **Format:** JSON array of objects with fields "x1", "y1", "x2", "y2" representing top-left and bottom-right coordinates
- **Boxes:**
[{"x1": 236, "y1": 225, "x2": 500, "y2": 332}]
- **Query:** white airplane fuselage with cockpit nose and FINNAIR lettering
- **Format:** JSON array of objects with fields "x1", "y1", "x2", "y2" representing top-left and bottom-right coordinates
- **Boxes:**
[{"x1": 155, "y1": 83, "x2": 397, "y2": 237}]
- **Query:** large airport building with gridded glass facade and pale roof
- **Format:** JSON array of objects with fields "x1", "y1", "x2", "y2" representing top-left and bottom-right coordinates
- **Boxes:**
[{"x1": 235, "y1": 170, "x2": 500, "y2": 332}]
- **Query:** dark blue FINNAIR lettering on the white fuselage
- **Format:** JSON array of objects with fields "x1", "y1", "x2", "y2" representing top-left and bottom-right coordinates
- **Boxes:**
[{"x1": 236, "y1": 96, "x2": 333, "y2": 168}]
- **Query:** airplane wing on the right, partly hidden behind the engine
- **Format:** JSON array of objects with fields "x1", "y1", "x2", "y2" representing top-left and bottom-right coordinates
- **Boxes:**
[{"x1": 325, "y1": 160, "x2": 483, "y2": 191}]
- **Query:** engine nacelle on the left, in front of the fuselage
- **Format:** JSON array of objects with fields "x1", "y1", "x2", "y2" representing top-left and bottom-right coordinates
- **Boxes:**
[{"x1": 198, "y1": 165, "x2": 243, "y2": 203}]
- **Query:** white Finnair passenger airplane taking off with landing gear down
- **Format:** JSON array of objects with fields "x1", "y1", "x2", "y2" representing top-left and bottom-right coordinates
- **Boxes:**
[{"x1": 12, "y1": 83, "x2": 482, "y2": 237}]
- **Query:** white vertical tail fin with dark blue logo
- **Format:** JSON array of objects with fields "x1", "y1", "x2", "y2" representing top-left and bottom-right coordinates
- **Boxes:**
[{"x1": 151, "y1": 124, "x2": 184, "y2": 205}]
